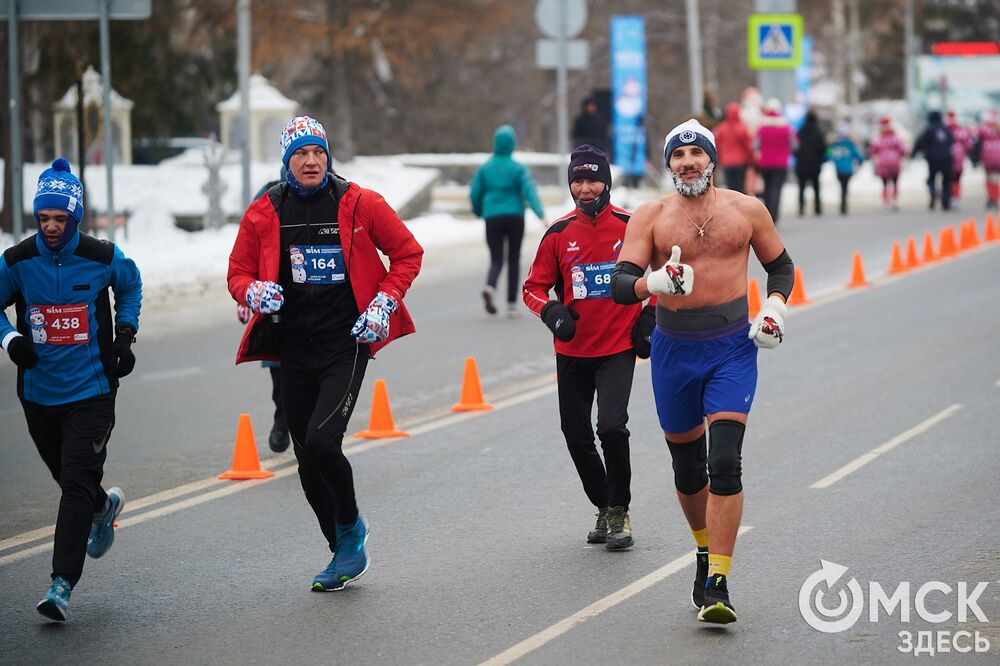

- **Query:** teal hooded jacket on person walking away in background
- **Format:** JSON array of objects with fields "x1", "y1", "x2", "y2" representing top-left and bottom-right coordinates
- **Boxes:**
[{"x1": 469, "y1": 125, "x2": 545, "y2": 220}]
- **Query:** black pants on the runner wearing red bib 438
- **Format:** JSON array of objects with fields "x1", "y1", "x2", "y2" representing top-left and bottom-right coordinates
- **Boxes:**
[{"x1": 21, "y1": 392, "x2": 115, "y2": 587}]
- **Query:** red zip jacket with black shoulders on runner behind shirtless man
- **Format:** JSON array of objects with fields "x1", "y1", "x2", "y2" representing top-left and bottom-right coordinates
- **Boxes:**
[{"x1": 523, "y1": 205, "x2": 642, "y2": 357}]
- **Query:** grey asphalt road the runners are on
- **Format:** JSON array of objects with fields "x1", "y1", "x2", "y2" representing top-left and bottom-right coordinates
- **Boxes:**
[{"x1": 0, "y1": 200, "x2": 1000, "y2": 664}]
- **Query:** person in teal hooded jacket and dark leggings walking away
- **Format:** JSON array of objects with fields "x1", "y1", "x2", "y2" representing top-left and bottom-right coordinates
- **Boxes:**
[{"x1": 469, "y1": 125, "x2": 545, "y2": 317}]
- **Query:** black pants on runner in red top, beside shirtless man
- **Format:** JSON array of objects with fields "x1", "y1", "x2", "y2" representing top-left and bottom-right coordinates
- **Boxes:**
[{"x1": 556, "y1": 349, "x2": 635, "y2": 511}]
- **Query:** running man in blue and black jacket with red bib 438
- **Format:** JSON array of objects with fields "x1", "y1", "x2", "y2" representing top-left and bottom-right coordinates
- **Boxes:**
[{"x1": 0, "y1": 158, "x2": 142, "y2": 621}]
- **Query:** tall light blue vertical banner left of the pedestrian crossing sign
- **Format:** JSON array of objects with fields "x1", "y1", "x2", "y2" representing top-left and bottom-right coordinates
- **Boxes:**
[{"x1": 611, "y1": 16, "x2": 648, "y2": 176}]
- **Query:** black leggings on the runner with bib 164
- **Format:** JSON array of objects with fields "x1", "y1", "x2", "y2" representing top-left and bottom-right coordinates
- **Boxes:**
[{"x1": 280, "y1": 342, "x2": 368, "y2": 551}]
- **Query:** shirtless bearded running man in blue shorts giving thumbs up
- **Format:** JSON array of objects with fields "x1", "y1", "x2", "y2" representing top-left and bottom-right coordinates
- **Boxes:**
[{"x1": 611, "y1": 119, "x2": 794, "y2": 624}]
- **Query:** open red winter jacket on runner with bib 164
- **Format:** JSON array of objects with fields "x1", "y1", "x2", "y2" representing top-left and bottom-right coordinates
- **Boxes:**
[{"x1": 227, "y1": 178, "x2": 424, "y2": 363}]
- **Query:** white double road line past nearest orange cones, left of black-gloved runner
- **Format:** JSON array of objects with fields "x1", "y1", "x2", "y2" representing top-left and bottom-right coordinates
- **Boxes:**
[{"x1": 0, "y1": 384, "x2": 557, "y2": 566}]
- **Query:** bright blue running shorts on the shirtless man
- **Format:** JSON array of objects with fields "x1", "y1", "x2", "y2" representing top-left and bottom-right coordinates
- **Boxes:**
[{"x1": 649, "y1": 322, "x2": 757, "y2": 433}]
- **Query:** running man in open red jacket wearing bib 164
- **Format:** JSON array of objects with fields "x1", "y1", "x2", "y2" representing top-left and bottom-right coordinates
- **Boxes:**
[{"x1": 228, "y1": 116, "x2": 423, "y2": 591}]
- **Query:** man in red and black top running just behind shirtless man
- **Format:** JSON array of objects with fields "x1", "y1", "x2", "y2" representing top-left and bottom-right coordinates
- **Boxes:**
[{"x1": 524, "y1": 144, "x2": 655, "y2": 550}]
